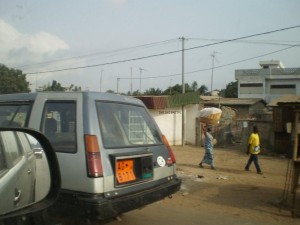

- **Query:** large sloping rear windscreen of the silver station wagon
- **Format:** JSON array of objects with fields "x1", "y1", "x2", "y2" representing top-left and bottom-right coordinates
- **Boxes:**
[{"x1": 96, "y1": 102, "x2": 162, "y2": 148}]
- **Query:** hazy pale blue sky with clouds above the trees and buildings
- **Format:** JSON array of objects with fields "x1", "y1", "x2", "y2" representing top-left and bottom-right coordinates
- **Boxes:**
[{"x1": 0, "y1": 0, "x2": 300, "y2": 93}]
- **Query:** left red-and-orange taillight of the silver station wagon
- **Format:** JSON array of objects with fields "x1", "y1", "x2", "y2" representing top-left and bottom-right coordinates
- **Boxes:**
[{"x1": 85, "y1": 135, "x2": 103, "y2": 177}]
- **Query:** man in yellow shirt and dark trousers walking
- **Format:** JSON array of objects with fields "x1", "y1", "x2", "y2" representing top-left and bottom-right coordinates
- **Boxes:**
[{"x1": 245, "y1": 126, "x2": 262, "y2": 174}]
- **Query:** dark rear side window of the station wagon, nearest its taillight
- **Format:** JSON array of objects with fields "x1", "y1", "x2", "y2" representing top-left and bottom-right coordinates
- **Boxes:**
[{"x1": 41, "y1": 101, "x2": 77, "y2": 153}]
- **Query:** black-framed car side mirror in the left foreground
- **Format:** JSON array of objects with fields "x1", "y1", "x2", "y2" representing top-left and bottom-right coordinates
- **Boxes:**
[{"x1": 0, "y1": 128, "x2": 61, "y2": 221}]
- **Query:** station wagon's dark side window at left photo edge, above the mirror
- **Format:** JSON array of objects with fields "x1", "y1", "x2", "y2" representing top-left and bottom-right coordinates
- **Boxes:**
[{"x1": 0, "y1": 104, "x2": 31, "y2": 127}]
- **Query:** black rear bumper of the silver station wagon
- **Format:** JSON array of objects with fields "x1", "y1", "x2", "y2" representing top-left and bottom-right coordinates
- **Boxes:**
[{"x1": 54, "y1": 177, "x2": 181, "y2": 219}]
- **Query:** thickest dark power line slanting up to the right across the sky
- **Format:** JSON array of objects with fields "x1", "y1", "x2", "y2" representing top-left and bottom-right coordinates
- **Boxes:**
[{"x1": 25, "y1": 25, "x2": 300, "y2": 75}]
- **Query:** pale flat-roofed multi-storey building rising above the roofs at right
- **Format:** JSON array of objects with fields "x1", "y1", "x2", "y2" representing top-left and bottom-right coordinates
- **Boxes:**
[{"x1": 235, "y1": 60, "x2": 300, "y2": 103}]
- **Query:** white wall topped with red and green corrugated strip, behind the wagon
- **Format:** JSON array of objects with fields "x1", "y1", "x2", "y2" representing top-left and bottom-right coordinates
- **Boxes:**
[{"x1": 137, "y1": 93, "x2": 200, "y2": 145}]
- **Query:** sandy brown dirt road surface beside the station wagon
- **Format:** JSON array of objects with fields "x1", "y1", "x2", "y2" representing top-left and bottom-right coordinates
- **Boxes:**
[{"x1": 107, "y1": 146, "x2": 300, "y2": 225}]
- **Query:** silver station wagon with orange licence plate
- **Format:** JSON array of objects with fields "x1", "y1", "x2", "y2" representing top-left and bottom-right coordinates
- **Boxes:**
[{"x1": 0, "y1": 92, "x2": 181, "y2": 219}]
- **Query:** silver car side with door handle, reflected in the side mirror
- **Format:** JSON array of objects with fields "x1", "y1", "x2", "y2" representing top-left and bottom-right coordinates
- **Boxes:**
[{"x1": 0, "y1": 131, "x2": 36, "y2": 214}]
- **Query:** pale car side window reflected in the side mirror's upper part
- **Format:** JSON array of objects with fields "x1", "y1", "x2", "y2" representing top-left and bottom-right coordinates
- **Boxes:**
[{"x1": 2, "y1": 131, "x2": 23, "y2": 168}]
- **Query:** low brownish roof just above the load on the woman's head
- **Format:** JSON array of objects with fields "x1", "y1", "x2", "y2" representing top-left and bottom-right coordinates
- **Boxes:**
[{"x1": 201, "y1": 98, "x2": 265, "y2": 106}]
